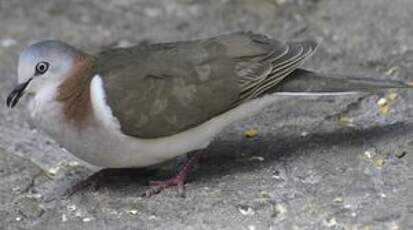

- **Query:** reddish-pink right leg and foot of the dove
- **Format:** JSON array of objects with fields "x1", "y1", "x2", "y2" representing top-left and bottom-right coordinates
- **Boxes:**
[{"x1": 144, "y1": 150, "x2": 203, "y2": 197}]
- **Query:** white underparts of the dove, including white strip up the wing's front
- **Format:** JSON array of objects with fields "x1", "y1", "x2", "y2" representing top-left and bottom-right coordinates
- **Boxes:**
[{"x1": 29, "y1": 76, "x2": 284, "y2": 168}]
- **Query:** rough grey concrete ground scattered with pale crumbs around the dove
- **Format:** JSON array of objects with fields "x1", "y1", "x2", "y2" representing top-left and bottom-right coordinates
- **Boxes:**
[{"x1": 0, "y1": 0, "x2": 413, "y2": 230}]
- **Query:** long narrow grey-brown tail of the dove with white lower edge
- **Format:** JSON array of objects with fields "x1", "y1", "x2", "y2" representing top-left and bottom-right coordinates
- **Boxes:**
[{"x1": 269, "y1": 69, "x2": 413, "y2": 95}]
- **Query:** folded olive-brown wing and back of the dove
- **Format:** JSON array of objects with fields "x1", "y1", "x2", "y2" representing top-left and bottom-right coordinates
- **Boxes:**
[{"x1": 96, "y1": 33, "x2": 316, "y2": 138}]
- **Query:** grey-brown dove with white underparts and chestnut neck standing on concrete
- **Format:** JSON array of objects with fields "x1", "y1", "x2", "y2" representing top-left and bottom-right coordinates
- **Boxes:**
[{"x1": 6, "y1": 32, "x2": 412, "y2": 196}]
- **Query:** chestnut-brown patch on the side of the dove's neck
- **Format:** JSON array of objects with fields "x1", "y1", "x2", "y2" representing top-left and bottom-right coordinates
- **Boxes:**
[{"x1": 56, "y1": 54, "x2": 95, "y2": 126}]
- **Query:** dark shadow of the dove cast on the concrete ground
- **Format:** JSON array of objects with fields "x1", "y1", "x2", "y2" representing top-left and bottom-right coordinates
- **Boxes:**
[{"x1": 67, "y1": 123, "x2": 413, "y2": 195}]
